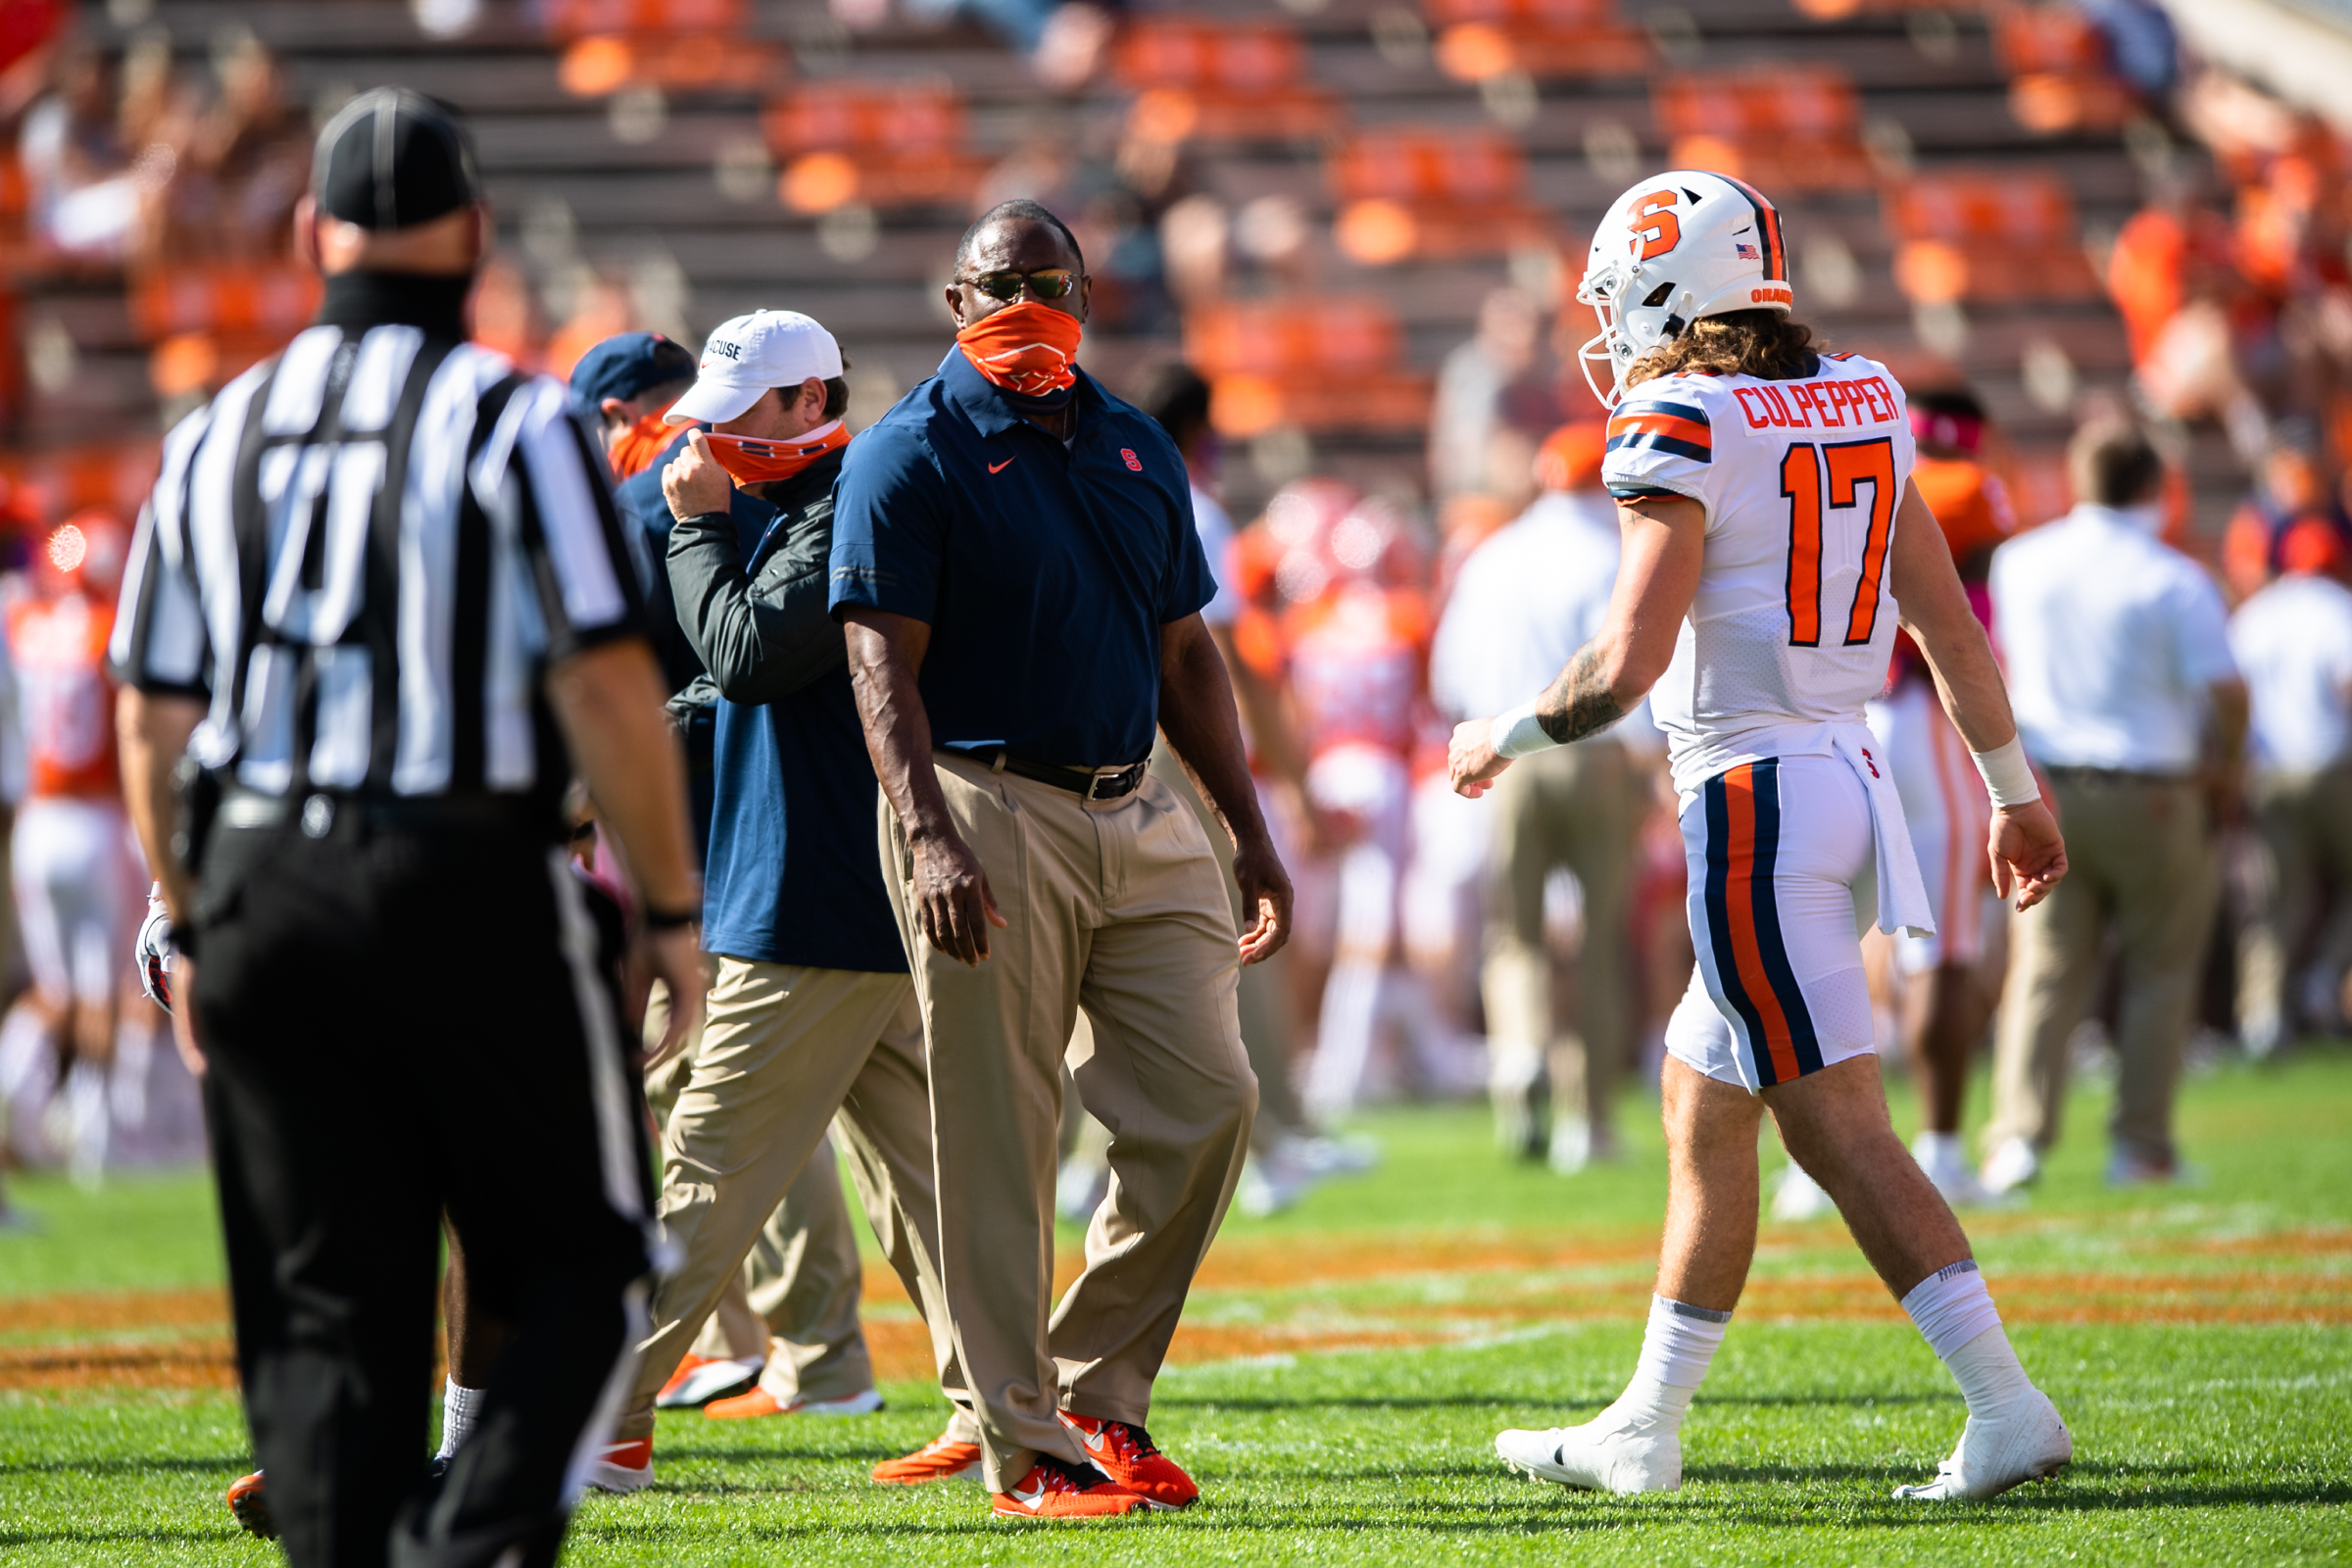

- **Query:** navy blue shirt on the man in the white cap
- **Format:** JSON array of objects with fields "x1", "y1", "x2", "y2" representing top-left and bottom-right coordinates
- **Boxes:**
[{"x1": 704, "y1": 446, "x2": 906, "y2": 973}]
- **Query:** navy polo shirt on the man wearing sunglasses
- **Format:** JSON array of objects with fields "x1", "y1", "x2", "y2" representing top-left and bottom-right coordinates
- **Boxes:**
[{"x1": 830, "y1": 350, "x2": 1216, "y2": 766}]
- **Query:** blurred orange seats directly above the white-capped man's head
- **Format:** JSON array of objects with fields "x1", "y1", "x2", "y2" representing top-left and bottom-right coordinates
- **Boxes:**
[{"x1": 762, "y1": 80, "x2": 988, "y2": 212}]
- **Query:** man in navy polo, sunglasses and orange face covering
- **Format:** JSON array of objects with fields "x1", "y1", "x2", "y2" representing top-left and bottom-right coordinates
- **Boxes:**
[{"x1": 833, "y1": 202, "x2": 1292, "y2": 1516}]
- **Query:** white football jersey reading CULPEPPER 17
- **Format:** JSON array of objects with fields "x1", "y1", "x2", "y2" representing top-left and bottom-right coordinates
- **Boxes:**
[{"x1": 1601, "y1": 355, "x2": 1912, "y2": 790}]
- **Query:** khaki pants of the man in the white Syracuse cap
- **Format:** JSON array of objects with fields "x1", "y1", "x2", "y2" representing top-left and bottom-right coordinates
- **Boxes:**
[{"x1": 616, "y1": 956, "x2": 971, "y2": 1441}]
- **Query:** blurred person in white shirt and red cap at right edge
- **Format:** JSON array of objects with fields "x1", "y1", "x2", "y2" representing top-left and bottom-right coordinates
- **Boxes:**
[{"x1": 2230, "y1": 524, "x2": 2352, "y2": 1057}]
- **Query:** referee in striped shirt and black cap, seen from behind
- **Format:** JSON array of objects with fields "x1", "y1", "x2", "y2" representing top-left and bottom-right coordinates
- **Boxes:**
[{"x1": 111, "y1": 89, "x2": 704, "y2": 1568}]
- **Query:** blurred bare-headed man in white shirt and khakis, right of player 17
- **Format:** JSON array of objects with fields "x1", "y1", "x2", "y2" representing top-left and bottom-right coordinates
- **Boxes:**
[{"x1": 1983, "y1": 420, "x2": 2246, "y2": 1192}]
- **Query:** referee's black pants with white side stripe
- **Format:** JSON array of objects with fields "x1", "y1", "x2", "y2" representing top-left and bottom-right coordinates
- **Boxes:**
[{"x1": 193, "y1": 804, "x2": 649, "y2": 1568}]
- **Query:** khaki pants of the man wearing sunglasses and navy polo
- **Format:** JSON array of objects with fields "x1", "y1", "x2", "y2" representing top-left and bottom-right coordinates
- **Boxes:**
[{"x1": 880, "y1": 753, "x2": 1258, "y2": 1491}]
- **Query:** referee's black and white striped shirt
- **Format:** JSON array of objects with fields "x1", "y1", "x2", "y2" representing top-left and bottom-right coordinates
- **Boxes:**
[{"x1": 111, "y1": 305, "x2": 642, "y2": 800}]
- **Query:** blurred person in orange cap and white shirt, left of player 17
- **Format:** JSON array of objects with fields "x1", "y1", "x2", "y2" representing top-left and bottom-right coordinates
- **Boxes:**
[{"x1": 1430, "y1": 423, "x2": 1660, "y2": 1175}]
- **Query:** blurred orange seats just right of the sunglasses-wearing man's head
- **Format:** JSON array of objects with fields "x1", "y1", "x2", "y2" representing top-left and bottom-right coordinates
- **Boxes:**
[{"x1": 1183, "y1": 296, "x2": 1430, "y2": 437}]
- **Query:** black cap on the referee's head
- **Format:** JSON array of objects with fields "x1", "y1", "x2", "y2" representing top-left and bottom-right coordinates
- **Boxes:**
[{"x1": 311, "y1": 87, "x2": 482, "y2": 228}]
